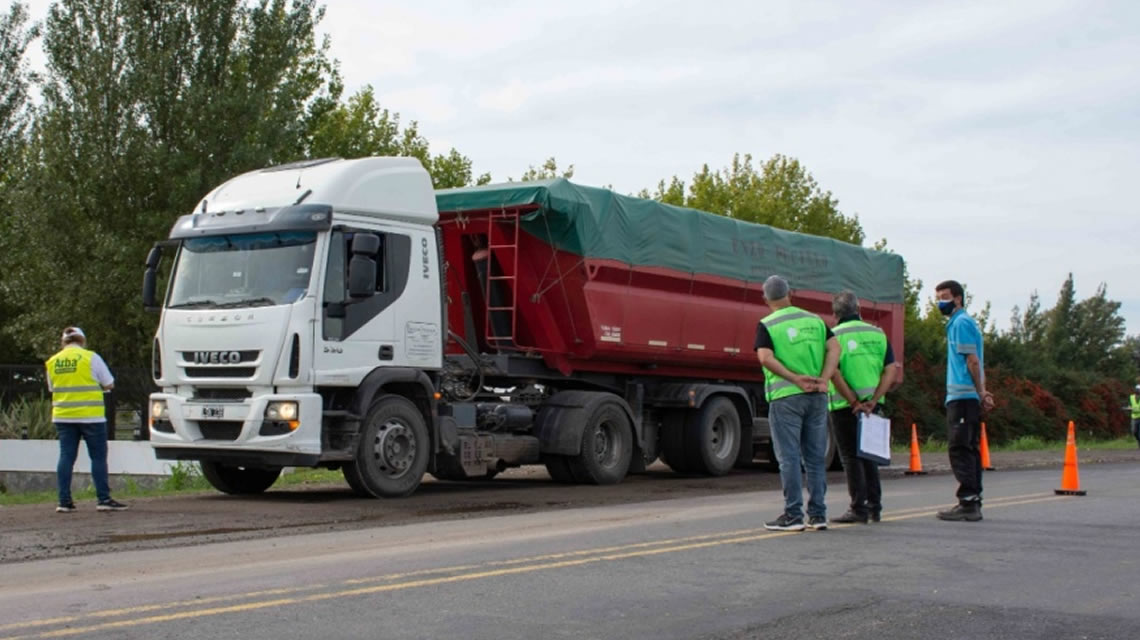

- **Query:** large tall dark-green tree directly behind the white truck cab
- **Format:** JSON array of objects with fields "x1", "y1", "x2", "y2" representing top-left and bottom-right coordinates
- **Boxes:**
[{"x1": 0, "y1": 0, "x2": 340, "y2": 366}]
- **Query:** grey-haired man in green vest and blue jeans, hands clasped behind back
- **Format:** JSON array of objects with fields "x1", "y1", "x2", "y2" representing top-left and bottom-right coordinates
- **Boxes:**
[{"x1": 755, "y1": 276, "x2": 839, "y2": 532}]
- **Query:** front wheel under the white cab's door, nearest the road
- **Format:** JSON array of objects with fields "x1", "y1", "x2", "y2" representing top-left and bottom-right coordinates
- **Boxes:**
[{"x1": 344, "y1": 395, "x2": 431, "y2": 497}]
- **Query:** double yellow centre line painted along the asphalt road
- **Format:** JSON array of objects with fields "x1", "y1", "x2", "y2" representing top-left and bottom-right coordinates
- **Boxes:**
[{"x1": 0, "y1": 493, "x2": 1067, "y2": 640}]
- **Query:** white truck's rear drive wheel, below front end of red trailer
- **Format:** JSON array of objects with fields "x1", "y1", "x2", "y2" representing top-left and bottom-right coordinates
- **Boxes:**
[{"x1": 568, "y1": 397, "x2": 634, "y2": 485}]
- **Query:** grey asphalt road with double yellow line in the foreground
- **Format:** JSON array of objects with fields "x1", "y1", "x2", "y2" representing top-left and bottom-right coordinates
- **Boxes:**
[{"x1": 0, "y1": 464, "x2": 1140, "y2": 640}]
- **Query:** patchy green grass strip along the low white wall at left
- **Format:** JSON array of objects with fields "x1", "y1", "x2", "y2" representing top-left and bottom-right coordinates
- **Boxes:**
[{"x1": 0, "y1": 462, "x2": 347, "y2": 505}]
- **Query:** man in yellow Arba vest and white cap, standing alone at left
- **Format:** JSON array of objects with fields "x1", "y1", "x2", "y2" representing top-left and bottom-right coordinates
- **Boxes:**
[{"x1": 44, "y1": 326, "x2": 127, "y2": 513}]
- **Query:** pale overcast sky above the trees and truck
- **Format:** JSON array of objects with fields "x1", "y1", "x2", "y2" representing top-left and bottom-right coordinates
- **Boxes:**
[{"x1": 17, "y1": 0, "x2": 1140, "y2": 333}]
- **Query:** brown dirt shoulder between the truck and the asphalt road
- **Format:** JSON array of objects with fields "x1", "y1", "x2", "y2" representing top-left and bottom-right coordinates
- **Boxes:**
[{"x1": 0, "y1": 449, "x2": 1140, "y2": 562}]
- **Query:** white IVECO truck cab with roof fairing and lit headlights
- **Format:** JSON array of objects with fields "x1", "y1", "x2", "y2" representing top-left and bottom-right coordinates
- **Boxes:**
[{"x1": 144, "y1": 157, "x2": 446, "y2": 495}]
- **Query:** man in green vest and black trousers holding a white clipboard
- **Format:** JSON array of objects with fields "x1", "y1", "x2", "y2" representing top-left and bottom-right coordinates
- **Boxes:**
[{"x1": 830, "y1": 291, "x2": 897, "y2": 525}]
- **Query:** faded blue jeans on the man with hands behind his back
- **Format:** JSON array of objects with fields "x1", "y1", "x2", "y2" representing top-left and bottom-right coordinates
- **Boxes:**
[{"x1": 768, "y1": 392, "x2": 828, "y2": 518}]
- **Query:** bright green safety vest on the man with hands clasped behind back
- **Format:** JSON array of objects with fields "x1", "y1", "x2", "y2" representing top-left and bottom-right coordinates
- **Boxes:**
[{"x1": 760, "y1": 307, "x2": 828, "y2": 403}]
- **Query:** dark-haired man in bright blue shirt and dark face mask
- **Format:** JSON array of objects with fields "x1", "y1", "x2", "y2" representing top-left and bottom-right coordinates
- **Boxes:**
[{"x1": 934, "y1": 280, "x2": 994, "y2": 522}]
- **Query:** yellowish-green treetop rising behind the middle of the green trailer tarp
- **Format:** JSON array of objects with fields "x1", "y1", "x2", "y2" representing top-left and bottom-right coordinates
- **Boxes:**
[{"x1": 640, "y1": 154, "x2": 864, "y2": 244}]
